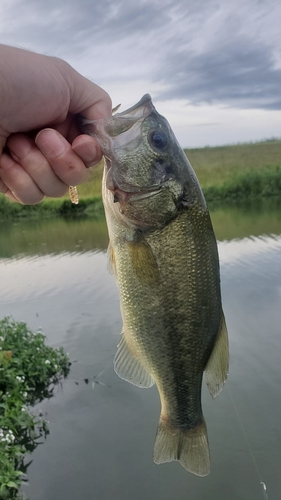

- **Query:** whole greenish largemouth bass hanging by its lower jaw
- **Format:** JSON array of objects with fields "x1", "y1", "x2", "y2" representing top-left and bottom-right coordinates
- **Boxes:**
[{"x1": 83, "y1": 94, "x2": 229, "y2": 477}]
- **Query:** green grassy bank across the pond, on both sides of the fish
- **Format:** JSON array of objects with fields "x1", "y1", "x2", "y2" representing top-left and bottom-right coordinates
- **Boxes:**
[{"x1": 0, "y1": 138, "x2": 281, "y2": 219}]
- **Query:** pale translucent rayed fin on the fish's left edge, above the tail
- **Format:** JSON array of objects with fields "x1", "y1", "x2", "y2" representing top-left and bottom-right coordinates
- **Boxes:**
[{"x1": 114, "y1": 333, "x2": 154, "y2": 388}]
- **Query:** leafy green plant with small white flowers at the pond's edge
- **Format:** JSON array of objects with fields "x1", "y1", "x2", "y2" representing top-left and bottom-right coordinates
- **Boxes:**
[{"x1": 0, "y1": 317, "x2": 70, "y2": 500}]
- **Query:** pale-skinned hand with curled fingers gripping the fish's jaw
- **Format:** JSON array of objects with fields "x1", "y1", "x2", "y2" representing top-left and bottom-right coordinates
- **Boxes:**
[{"x1": 0, "y1": 45, "x2": 112, "y2": 204}]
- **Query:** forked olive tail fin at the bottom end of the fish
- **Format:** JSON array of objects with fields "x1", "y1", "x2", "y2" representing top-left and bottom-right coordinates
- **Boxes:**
[{"x1": 153, "y1": 419, "x2": 210, "y2": 476}]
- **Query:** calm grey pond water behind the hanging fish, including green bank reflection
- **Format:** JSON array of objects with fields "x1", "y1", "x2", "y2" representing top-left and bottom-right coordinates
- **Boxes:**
[{"x1": 0, "y1": 199, "x2": 281, "y2": 500}]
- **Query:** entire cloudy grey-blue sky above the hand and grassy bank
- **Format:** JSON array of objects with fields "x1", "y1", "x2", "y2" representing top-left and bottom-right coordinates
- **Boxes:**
[{"x1": 0, "y1": 0, "x2": 281, "y2": 147}]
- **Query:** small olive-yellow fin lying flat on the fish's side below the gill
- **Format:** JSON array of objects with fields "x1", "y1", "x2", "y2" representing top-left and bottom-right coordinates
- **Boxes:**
[{"x1": 127, "y1": 239, "x2": 159, "y2": 285}]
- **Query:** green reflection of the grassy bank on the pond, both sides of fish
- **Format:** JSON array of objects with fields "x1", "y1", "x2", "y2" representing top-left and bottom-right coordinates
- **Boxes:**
[{"x1": 0, "y1": 197, "x2": 281, "y2": 258}]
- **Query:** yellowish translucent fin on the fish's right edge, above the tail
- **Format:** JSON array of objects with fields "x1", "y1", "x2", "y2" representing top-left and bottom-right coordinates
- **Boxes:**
[{"x1": 205, "y1": 312, "x2": 229, "y2": 398}]
